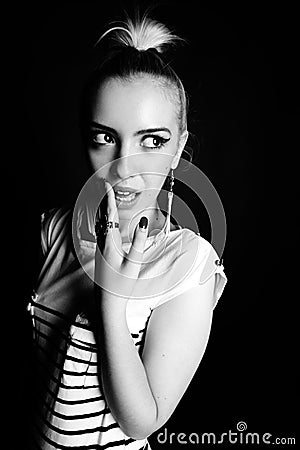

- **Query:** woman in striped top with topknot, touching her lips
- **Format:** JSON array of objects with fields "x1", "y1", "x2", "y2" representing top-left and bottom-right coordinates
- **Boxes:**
[{"x1": 28, "y1": 14, "x2": 227, "y2": 450}]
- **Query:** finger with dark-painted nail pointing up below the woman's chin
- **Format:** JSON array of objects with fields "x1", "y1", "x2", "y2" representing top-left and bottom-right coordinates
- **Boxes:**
[{"x1": 125, "y1": 216, "x2": 148, "y2": 278}]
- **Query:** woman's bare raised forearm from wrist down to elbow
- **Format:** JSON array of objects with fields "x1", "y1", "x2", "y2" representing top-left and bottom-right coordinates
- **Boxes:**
[{"x1": 98, "y1": 295, "x2": 157, "y2": 439}]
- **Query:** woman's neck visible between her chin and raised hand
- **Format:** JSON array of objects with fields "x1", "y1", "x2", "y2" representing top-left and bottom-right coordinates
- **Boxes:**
[{"x1": 119, "y1": 203, "x2": 166, "y2": 244}]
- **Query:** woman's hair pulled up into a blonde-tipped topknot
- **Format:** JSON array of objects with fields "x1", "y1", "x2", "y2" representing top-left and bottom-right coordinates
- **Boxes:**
[{"x1": 80, "y1": 15, "x2": 187, "y2": 134}]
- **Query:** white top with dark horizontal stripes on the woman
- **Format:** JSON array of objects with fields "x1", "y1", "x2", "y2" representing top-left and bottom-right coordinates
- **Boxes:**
[{"x1": 29, "y1": 209, "x2": 227, "y2": 450}]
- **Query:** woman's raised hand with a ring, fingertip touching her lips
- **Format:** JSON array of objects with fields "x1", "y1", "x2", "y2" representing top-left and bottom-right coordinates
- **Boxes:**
[{"x1": 95, "y1": 181, "x2": 148, "y2": 300}]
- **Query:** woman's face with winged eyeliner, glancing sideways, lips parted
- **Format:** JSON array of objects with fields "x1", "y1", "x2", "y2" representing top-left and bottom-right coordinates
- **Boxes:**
[{"x1": 87, "y1": 76, "x2": 186, "y2": 218}]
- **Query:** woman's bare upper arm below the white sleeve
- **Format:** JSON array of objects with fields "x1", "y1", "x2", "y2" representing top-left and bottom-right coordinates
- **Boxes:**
[{"x1": 142, "y1": 276, "x2": 215, "y2": 429}]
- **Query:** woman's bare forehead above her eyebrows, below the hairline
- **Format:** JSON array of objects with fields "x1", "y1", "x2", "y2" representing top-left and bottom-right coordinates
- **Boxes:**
[{"x1": 91, "y1": 77, "x2": 178, "y2": 132}]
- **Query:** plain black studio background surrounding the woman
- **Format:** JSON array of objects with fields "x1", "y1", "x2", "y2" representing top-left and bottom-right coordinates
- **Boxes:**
[{"x1": 4, "y1": 1, "x2": 299, "y2": 450}]
